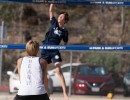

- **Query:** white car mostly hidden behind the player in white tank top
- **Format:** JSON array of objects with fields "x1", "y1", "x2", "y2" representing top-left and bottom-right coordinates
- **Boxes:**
[{"x1": 7, "y1": 67, "x2": 53, "y2": 94}]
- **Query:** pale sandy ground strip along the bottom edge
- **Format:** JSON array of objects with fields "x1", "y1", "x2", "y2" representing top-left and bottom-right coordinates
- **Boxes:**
[{"x1": 0, "y1": 92, "x2": 130, "y2": 100}]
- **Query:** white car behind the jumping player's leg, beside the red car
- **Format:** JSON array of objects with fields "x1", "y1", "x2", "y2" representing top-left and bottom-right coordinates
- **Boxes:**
[{"x1": 48, "y1": 63, "x2": 81, "y2": 88}]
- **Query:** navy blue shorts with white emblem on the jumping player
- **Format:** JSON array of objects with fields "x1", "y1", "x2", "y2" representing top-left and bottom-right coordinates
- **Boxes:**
[{"x1": 41, "y1": 50, "x2": 62, "y2": 64}]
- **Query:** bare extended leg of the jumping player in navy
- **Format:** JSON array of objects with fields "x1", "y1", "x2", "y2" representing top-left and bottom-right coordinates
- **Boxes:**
[{"x1": 55, "y1": 63, "x2": 69, "y2": 100}]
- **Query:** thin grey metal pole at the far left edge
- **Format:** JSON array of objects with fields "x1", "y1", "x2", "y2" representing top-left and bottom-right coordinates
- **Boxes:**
[{"x1": 0, "y1": 21, "x2": 4, "y2": 86}]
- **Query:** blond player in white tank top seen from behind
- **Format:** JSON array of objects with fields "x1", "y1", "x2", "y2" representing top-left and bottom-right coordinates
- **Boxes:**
[{"x1": 14, "y1": 40, "x2": 50, "y2": 100}]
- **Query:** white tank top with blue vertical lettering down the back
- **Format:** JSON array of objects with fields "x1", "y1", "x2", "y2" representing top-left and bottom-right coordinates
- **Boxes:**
[{"x1": 18, "y1": 57, "x2": 46, "y2": 95}]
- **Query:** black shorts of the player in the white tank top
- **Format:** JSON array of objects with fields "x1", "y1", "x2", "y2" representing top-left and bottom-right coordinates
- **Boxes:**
[{"x1": 14, "y1": 93, "x2": 50, "y2": 100}]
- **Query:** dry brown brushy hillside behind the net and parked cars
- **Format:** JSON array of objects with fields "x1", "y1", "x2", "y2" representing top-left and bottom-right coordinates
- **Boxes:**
[{"x1": 0, "y1": 3, "x2": 130, "y2": 85}]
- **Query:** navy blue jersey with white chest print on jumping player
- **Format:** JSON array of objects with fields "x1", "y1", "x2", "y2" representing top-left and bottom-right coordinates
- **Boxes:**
[{"x1": 43, "y1": 17, "x2": 68, "y2": 45}]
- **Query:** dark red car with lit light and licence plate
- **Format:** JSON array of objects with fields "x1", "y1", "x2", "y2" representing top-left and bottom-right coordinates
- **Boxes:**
[{"x1": 72, "y1": 64, "x2": 115, "y2": 94}]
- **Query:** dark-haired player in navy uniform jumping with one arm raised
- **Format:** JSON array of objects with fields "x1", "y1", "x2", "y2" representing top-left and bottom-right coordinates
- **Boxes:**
[{"x1": 41, "y1": 4, "x2": 69, "y2": 100}]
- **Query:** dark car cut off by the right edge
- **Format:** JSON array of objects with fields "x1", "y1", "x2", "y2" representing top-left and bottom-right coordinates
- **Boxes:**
[{"x1": 123, "y1": 71, "x2": 130, "y2": 96}]
